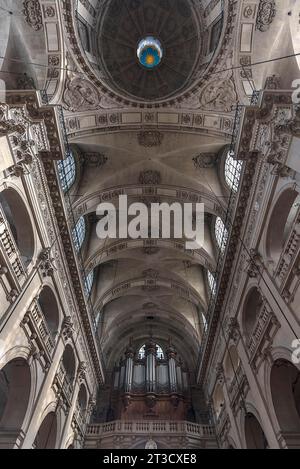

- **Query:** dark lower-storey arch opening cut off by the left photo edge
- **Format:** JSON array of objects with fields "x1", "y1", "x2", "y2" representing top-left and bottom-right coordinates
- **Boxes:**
[{"x1": 0, "y1": 358, "x2": 31, "y2": 445}]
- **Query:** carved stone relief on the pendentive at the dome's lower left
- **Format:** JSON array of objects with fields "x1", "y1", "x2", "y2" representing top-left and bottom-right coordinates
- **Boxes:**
[{"x1": 64, "y1": 77, "x2": 100, "y2": 111}]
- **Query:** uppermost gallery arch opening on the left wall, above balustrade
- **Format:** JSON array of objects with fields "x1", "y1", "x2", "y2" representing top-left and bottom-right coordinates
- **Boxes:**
[{"x1": 0, "y1": 187, "x2": 34, "y2": 267}]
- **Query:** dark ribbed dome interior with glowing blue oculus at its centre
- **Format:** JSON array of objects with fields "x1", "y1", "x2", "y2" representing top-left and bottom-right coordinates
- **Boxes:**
[{"x1": 97, "y1": 0, "x2": 203, "y2": 101}]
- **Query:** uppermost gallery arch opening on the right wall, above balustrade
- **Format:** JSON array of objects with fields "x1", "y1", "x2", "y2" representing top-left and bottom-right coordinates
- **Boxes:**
[{"x1": 266, "y1": 188, "x2": 300, "y2": 264}]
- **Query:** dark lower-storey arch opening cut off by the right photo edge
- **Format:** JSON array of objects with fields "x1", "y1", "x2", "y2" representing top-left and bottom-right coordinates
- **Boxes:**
[{"x1": 270, "y1": 360, "x2": 300, "y2": 447}]
